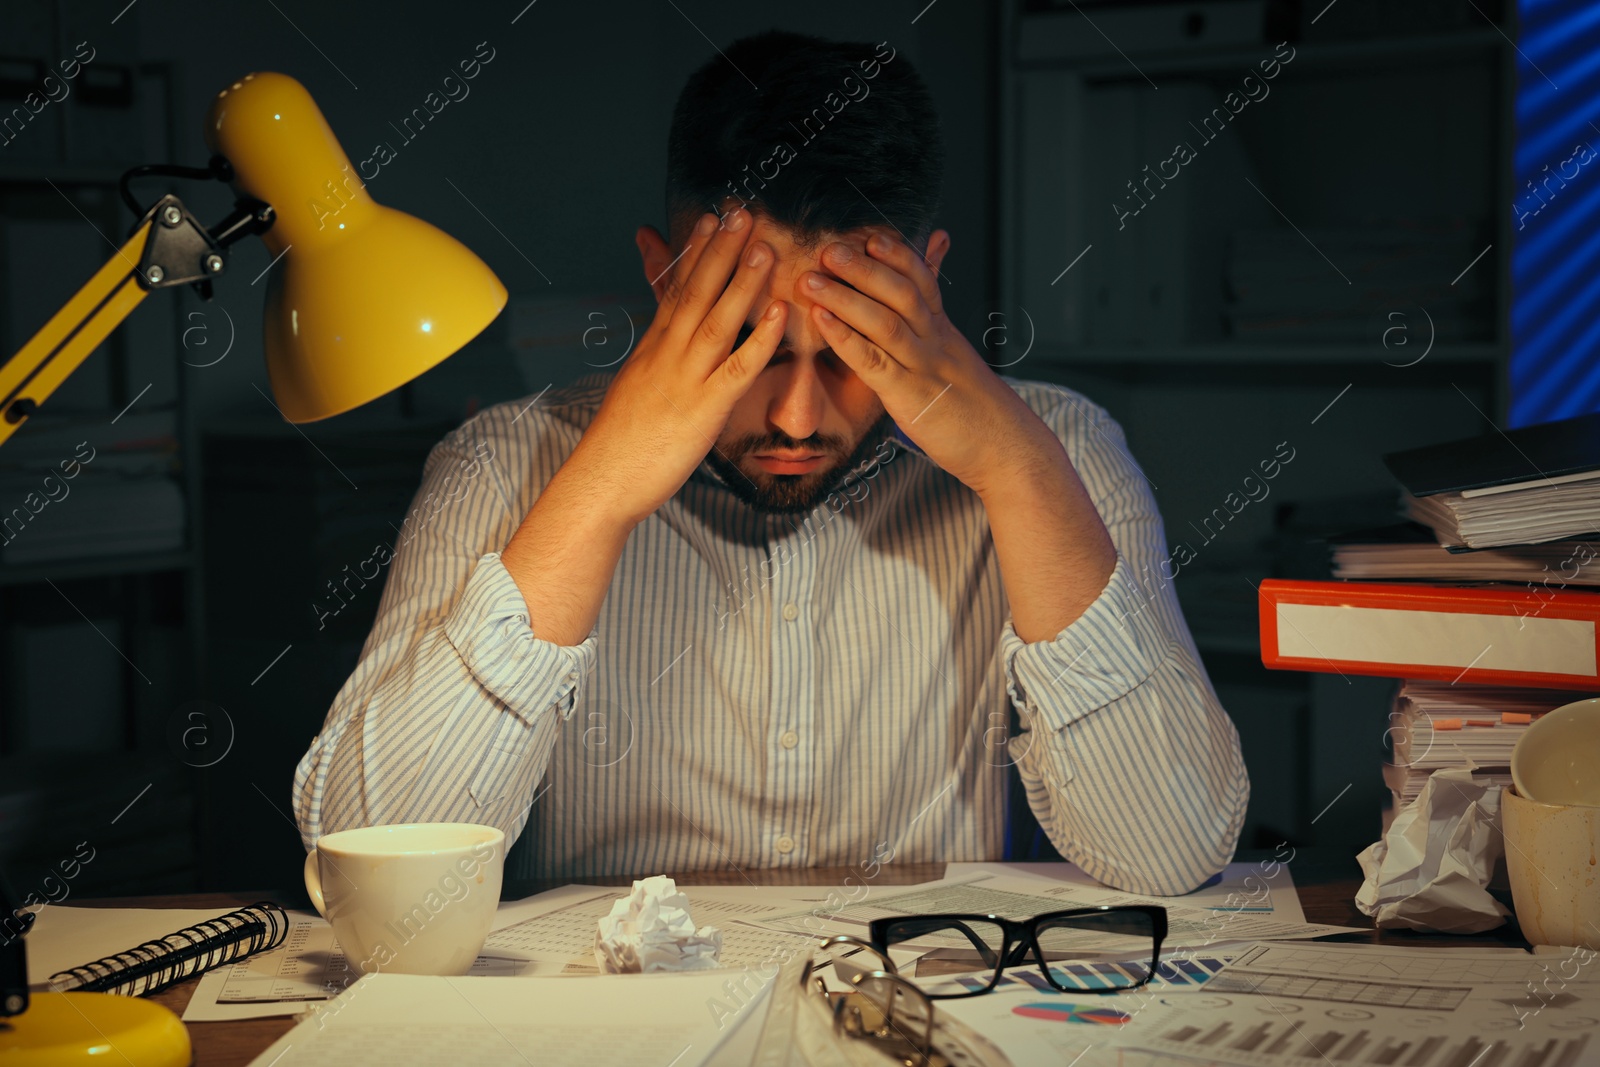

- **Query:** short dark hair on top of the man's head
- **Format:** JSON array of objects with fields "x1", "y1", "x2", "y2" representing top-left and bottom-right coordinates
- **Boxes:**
[{"x1": 667, "y1": 30, "x2": 944, "y2": 248}]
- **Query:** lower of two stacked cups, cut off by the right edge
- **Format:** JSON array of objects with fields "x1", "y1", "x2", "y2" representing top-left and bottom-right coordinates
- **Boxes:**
[{"x1": 1501, "y1": 787, "x2": 1600, "y2": 949}]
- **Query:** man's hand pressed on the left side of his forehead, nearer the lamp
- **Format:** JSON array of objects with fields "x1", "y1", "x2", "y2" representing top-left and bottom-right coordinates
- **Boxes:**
[{"x1": 568, "y1": 208, "x2": 787, "y2": 526}]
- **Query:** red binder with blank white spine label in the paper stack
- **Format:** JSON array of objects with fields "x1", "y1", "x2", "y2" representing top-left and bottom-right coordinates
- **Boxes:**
[{"x1": 1259, "y1": 577, "x2": 1600, "y2": 689}]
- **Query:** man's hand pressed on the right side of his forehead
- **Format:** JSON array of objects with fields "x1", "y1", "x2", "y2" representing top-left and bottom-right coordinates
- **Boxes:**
[{"x1": 797, "y1": 234, "x2": 1064, "y2": 496}]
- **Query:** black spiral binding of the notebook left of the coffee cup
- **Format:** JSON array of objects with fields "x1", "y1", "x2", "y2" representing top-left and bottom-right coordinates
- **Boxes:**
[{"x1": 50, "y1": 901, "x2": 290, "y2": 997}]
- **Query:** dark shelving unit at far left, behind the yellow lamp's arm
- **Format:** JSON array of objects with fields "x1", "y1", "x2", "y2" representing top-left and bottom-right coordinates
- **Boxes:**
[{"x1": 0, "y1": 20, "x2": 205, "y2": 891}]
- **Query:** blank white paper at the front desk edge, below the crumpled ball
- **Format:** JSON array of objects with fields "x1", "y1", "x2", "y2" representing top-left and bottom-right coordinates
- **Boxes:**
[{"x1": 253, "y1": 971, "x2": 758, "y2": 1067}]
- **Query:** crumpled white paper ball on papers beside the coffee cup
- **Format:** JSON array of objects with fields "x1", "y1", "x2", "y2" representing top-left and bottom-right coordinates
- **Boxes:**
[{"x1": 595, "y1": 875, "x2": 722, "y2": 974}]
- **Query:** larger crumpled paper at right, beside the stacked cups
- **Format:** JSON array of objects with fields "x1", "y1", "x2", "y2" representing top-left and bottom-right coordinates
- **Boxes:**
[{"x1": 1355, "y1": 768, "x2": 1510, "y2": 934}]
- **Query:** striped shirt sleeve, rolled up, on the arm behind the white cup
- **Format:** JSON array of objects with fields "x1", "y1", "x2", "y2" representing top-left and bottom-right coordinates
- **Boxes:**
[{"x1": 293, "y1": 410, "x2": 597, "y2": 848}]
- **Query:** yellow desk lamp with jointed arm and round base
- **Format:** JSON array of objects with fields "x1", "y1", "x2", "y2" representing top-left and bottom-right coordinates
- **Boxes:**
[{"x1": 0, "y1": 74, "x2": 506, "y2": 1067}]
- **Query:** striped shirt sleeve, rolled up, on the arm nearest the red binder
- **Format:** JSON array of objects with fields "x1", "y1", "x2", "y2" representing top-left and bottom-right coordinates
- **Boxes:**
[{"x1": 1000, "y1": 390, "x2": 1250, "y2": 896}]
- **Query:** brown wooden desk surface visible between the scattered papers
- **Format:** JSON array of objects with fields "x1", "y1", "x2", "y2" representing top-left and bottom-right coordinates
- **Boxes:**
[{"x1": 74, "y1": 849, "x2": 1528, "y2": 1067}]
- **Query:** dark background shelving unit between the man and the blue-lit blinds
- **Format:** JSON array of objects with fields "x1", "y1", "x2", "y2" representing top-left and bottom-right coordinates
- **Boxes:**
[{"x1": 987, "y1": 0, "x2": 1517, "y2": 846}]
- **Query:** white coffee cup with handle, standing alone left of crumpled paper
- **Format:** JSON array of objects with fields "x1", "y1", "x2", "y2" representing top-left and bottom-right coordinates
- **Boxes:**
[{"x1": 306, "y1": 822, "x2": 506, "y2": 974}]
